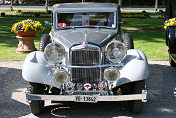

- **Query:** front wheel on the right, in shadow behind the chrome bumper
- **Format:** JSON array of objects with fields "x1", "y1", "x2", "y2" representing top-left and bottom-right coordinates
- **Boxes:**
[{"x1": 129, "y1": 80, "x2": 145, "y2": 114}]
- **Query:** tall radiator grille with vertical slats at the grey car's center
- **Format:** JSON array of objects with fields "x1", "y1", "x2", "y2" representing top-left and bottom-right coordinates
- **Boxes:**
[{"x1": 70, "y1": 44, "x2": 101, "y2": 84}]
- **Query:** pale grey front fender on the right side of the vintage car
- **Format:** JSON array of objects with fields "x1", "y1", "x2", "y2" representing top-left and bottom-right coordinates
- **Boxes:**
[{"x1": 113, "y1": 49, "x2": 149, "y2": 86}]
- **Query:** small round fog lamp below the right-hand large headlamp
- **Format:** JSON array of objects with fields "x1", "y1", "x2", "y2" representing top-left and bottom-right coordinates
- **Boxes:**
[{"x1": 104, "y1": 67, "x2": 120, "y2": 82}]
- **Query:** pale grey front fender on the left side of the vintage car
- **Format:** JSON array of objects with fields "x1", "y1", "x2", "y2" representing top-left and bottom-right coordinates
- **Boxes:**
[{"x1": 22, "y1": 51, "x2": 60, "y2": 88}]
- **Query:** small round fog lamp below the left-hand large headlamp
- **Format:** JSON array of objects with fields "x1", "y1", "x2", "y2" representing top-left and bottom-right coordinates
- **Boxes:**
[{"x1": 53, "y1": 70, "x2": 70, "y2": 84}]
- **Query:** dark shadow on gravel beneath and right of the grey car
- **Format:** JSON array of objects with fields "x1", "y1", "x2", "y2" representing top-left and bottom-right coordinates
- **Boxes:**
[{"x1": 40, "y1": 64, "x2": 176, "y2": 118}]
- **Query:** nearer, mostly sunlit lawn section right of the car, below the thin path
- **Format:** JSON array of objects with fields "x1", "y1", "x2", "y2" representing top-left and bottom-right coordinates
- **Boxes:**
[{"x1": 130, "y1": 32, "x2": 168, "y2": 60}]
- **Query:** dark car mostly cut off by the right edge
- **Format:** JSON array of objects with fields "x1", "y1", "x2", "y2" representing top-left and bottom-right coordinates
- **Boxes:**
[{"x1": 165, "y1": 0, "x2": 176, "y2": 67}]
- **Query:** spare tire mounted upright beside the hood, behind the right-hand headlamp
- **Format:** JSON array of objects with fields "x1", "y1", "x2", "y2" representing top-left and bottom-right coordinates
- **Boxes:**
[{"x1": 122, "y1": 33, "x2": 134, "y2": 50}]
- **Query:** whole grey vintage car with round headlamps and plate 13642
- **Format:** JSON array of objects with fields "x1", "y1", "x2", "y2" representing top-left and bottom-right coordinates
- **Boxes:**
[{"x1": 22, "y1": 3, "x2": 149, "y2": 115}]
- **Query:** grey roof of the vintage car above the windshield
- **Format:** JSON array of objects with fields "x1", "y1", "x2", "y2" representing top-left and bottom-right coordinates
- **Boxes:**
[{"x1": 52, "y1": 2, "x2": 118, "y2": 11}]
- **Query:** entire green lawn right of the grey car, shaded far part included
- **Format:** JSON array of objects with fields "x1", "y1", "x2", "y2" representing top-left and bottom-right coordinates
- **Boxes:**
[{"x1": 122, "y1": 18, "x2": 168, "y2": 60}]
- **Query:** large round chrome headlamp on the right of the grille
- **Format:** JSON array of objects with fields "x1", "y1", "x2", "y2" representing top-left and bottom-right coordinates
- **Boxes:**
[{"x1": 105, "y1": 40, "x2": 127, "y2": 63}]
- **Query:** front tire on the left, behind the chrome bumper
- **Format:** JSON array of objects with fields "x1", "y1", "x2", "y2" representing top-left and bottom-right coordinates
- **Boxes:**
[{"x1": 27, "y1": 83, "x2": 45, "y2": 116}]
